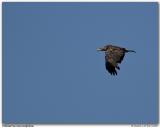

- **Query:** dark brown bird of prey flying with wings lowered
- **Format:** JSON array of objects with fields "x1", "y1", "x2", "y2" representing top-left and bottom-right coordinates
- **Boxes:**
[{"x1": 97, "y1": 45, "x2": 136, "y2": 75}]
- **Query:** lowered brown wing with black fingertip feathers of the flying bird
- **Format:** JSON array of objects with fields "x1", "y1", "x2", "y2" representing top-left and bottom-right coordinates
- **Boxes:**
[{"x1": 105, "y1": 47, "x2": 125, "y2": 75}]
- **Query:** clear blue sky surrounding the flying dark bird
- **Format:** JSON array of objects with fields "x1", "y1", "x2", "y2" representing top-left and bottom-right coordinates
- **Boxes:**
[{"x1": 2, "y1": 3, "x2": 158, "y2": 124}]
